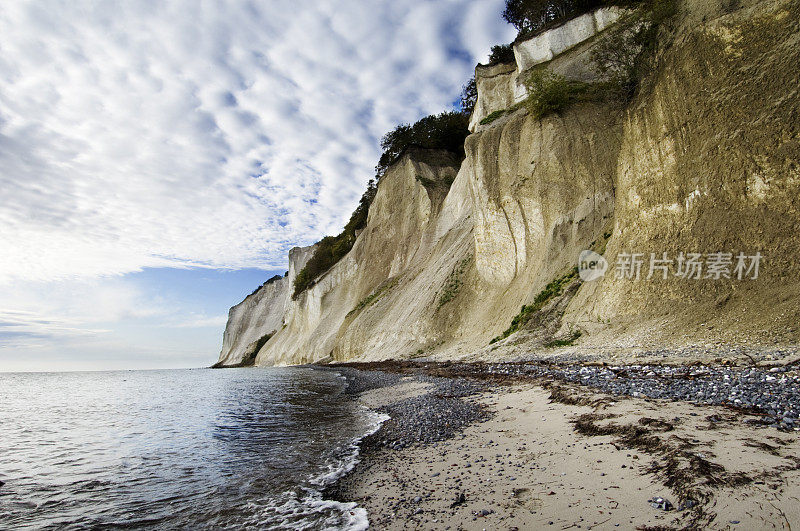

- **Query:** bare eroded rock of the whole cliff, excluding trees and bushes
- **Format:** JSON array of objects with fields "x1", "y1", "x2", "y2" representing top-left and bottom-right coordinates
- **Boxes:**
[{"x1": 223, "y1": 0, "x2": 800, "y2": 365}]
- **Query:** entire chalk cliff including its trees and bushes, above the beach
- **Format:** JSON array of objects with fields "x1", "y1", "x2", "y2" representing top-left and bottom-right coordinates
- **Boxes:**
[{"x1": 218, "y1": 0, "x2": 800, "y2": 366}]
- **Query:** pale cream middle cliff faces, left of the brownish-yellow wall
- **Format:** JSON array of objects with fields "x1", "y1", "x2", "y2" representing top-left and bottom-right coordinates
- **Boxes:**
[{"x1": 247, "y1": 97, "x2": 619, "y2": 365}]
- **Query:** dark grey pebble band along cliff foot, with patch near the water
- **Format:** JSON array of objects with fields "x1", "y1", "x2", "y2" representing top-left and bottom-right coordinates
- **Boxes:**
[{"x1": 328, "y1": 362, "x2": 800, "y2": 442}]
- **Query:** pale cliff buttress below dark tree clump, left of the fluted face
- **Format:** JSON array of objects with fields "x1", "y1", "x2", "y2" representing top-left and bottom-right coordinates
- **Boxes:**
[{"x1": 257, "y1": 150, "x2": 466, "y2": 365}]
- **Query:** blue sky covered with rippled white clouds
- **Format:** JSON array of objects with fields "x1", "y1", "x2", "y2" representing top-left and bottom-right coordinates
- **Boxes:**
[{"x1": 0, "y1": 0, "x2": 514, "y2": 371}]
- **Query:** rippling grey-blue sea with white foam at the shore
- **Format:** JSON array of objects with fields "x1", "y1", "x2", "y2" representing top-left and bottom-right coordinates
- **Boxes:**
[{"x1": 0, "y1": 368, "x2": 385, "y2": 530}]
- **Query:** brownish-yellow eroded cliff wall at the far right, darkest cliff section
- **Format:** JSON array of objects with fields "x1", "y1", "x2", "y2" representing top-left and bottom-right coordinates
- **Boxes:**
[{"x1": 567, "y1": 0, "x2": 800, "y2": 354}]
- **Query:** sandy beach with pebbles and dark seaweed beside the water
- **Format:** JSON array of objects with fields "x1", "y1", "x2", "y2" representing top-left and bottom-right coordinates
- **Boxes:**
[{"x1": 325, "y1": 362, "x2": 800, "y2": 529}]
